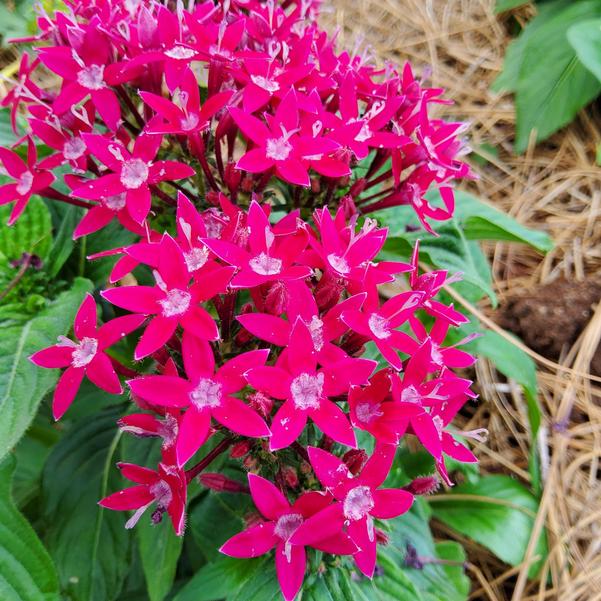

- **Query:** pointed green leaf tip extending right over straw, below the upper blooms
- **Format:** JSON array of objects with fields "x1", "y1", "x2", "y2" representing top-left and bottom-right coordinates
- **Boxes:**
[{"x1": 454, "y1": 190, "x2": 553, "y2": 252}]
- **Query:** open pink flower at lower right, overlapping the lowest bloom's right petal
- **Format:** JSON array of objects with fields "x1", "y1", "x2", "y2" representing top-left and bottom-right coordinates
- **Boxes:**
[{"x1": 290, "y1": 445, "x2": 413, "y2": 578}]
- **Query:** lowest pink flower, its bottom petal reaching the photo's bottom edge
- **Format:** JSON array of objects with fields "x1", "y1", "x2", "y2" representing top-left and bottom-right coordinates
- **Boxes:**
[{"x1": 220, "y1": 474, "x2": 357, "y2": 601}]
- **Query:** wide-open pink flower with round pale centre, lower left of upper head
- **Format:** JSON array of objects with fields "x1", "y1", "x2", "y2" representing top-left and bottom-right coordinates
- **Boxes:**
[{"x1": 73, "y1": 134, "x2": 194, "y2": 223}]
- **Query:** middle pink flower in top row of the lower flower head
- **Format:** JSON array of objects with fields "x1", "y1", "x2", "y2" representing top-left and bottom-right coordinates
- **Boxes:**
[{"x1": 203, "y1": 201, "x2": 311, "y2": 288}]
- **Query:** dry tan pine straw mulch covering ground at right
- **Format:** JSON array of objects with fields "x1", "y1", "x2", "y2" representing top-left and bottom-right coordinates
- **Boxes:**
[{"x1": 325, "y1": 0, "x2": 601, "y2": 601}]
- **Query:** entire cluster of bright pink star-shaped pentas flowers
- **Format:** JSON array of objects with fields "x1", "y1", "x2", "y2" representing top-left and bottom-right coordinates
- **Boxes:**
[{"x1": 0, "y1": 0, "x2": 475, "y2": 599}]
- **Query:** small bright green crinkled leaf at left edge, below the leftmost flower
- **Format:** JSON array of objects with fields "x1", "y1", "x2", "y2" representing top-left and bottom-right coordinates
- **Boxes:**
[{"x1": 0, "y1": 196, "x2": 52, "y2": 260}]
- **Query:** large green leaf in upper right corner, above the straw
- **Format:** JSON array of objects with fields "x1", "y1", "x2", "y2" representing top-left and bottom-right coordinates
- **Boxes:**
[{"x1": 515, "y1": 0, "x2": 601, "y2": 153}]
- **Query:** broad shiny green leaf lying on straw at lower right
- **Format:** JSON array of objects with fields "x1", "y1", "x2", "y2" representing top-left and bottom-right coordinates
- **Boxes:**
[{"x1": 430, "y1": 475, "x2": 547, "y2": 577}]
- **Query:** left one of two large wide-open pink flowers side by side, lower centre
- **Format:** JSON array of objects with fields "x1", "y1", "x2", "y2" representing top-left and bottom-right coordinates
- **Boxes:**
[{"x1": 128, "y1": 336, "x2": 270, "y2": 465}]
